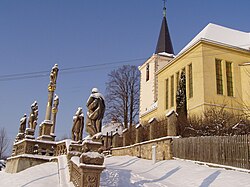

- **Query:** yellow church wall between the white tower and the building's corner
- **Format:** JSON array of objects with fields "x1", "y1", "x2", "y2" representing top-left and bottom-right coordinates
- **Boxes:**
[{"x1": 157, "y1": 45, "x2": 204, "y2": 116}]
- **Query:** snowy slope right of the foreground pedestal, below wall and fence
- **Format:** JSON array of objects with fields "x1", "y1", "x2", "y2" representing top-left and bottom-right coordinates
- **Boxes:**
[{"x1": 101, "y1": 156, "x2": 250, "y2": 187}]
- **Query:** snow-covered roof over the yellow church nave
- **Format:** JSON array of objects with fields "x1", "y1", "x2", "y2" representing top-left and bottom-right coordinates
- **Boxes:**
[{"x1": 178, "y1": 23, "x2": 250, "y2": 55}]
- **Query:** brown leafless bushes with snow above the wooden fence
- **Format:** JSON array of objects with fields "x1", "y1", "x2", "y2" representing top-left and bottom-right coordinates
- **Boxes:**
[{"x1": 183, "y1": 107, "x2": 250, "y2": 137}]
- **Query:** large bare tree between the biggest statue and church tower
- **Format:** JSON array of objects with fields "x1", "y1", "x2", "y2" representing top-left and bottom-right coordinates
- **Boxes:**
[{"x1": 106, "y1": 65, "x2": 140, "y2": 128}]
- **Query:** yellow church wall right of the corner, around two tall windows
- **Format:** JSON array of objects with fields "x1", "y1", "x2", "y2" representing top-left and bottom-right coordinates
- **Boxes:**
[{"x1": 203, "y1": 44, "x2": 250, "y2": 114}]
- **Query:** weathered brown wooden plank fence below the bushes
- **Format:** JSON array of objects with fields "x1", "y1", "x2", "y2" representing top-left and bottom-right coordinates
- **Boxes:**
[{"x1": 173, "y1": 135, "x2": 250, "y2": 169}]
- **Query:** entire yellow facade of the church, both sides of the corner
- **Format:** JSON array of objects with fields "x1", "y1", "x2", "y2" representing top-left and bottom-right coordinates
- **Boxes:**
[{"x1": 140, "y1": 39, "x2": 250, "y2": 121}]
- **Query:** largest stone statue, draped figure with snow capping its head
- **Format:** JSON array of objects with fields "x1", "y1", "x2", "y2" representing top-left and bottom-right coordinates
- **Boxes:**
[{"x1": 86, "y1": 88, "x2": 105, "y2": 137}]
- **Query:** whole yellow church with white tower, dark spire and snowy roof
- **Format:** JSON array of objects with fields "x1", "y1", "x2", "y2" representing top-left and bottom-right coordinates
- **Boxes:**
[{"x1": 139, "y1": 5, "x2": 250, "y2": 122}]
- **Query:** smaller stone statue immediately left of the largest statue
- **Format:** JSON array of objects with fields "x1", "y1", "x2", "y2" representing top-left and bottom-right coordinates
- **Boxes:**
[{"x1": 72, "y1": 107, "x2": 84, "y2": 141}]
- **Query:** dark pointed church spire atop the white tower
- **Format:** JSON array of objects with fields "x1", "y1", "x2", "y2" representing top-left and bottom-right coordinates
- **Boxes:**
[{"x1": 155, "y1": 0, "x2": 174, "y2": 54}]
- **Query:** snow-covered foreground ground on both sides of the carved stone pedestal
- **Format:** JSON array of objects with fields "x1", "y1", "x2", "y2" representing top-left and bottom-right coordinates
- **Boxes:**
[{"x1": 0, "y1": 156, "x2": 250, "y2": 187}]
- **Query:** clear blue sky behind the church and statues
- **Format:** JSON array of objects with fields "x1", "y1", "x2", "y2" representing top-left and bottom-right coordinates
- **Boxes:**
[{"x1": 0, "y1": 0, "x2": 250, "y2": 143}]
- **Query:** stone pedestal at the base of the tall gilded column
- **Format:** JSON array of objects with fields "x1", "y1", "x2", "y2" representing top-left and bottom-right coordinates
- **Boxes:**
[{"x1": 37, "y1": 120, "x2": 53, "y2": 141}]
